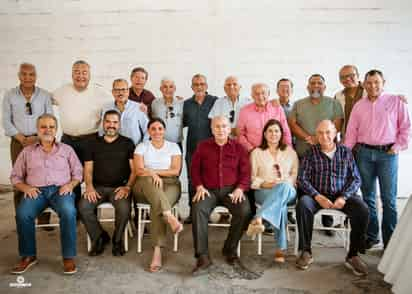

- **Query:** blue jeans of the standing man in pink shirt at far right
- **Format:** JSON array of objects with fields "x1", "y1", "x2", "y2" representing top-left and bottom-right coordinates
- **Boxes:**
[{"x1": 356, "y1": 146, "x2": 398, "y2": 246}]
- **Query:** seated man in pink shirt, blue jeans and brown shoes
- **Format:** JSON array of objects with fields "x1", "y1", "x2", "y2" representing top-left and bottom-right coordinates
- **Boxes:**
[{"x1": 10, "y1": 114, "x2": 82, "y2": 274}]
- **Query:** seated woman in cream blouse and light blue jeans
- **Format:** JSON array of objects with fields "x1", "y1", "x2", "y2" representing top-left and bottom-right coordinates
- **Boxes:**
[{"x1": 247, "y1": 119, "x2": 298, "y2": 262}]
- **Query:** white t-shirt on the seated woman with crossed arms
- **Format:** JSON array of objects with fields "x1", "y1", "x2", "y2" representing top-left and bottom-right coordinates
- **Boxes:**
[{"x1": 134, "y1": 140, "x2": 182, "y2": 170}]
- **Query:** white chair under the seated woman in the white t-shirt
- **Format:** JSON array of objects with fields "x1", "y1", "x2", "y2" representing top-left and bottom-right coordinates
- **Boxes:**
[{"x1": 136, "y1": 203, "x2": 179, "y2": 253}]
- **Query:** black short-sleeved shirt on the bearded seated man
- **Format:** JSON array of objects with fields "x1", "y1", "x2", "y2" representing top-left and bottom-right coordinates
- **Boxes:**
[{"x1": 84, "y1": 136, "x2": 135, "y2": 187}]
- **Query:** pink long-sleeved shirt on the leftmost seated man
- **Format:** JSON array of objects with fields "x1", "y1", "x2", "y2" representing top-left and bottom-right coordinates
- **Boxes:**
[{"x1": 10, "y1": 142, "x2": 83, "y2": 187}]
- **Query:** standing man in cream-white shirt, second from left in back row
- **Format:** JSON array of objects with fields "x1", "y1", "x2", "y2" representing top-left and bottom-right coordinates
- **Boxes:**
[{"x1": 53, "y1": 60, "x2": 112, "y2": 203}]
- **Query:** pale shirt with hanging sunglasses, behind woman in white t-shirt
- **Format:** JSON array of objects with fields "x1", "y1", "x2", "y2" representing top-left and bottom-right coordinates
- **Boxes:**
[{"x1": 152, "y1": 97, "x2": 184, "y2": 143}]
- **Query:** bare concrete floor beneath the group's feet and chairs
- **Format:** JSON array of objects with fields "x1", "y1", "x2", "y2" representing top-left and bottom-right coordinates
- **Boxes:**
[{"x1": 0, "y1": 187, "x2": 396, "y2": 294}]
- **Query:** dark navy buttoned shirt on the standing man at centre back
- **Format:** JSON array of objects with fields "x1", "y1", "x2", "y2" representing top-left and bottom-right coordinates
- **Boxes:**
[{"x1": 183, "y1": 94, "x2": 217, "y2": 157}]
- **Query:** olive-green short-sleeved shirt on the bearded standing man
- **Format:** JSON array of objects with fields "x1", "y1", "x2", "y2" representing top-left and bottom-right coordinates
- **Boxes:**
[{"x1": 289, "y1": 96, "x2": 343, "y2": 157}]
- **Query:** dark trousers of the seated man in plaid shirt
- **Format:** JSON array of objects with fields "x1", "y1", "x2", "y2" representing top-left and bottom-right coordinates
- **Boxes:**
[{"x1": 296, "y1": 195, "x2": 369, "y2": 257}]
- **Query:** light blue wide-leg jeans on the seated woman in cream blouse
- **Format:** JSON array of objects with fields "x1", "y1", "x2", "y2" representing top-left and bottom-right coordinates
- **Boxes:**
[{"x1": 255, "y1": 183, "x2": 296, "y2": 249}]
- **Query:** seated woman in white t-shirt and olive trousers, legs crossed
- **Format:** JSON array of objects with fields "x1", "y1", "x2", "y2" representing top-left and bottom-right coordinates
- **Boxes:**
[{"x1": 133, "y1": 118, "x2": 183, "y2": 272}]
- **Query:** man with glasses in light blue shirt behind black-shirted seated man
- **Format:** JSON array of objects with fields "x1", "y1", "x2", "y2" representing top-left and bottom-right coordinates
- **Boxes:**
[{"x1": 99, "y1": 79, "x2": 149, "y2": 145}]
